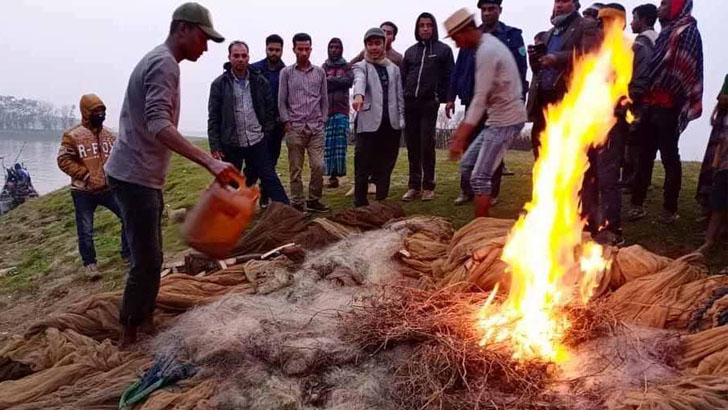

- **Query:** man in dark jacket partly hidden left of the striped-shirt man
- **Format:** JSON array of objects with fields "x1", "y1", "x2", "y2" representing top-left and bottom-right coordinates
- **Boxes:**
[{"x1": 250, "y1": 34, "x2": 286, "y2": 208}]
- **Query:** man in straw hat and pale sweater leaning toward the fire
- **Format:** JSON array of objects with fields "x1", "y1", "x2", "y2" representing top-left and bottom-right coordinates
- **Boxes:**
[{"x1": 445, "y1": 9, "x2": 526, "y2": 218}]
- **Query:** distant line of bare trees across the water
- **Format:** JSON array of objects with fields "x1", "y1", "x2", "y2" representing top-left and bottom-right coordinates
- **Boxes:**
[{"x1": 0, "y1": 95, "x2": 79, "y2": 130}]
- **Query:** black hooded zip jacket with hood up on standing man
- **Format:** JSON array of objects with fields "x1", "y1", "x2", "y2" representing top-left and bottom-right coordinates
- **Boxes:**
[{"x1": 400, "y1": 13, "x2": 455, "y2": 103}]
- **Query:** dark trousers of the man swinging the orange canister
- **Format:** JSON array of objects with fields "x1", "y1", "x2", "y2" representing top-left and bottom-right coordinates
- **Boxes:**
[{"x1": 109, "y1": 177, "x2": 164, "y2": 326}]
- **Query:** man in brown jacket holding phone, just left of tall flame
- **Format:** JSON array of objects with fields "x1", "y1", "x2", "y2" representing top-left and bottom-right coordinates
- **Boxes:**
[{"x1": 526, "y1": 0, "x2": 600, "y2": 158}]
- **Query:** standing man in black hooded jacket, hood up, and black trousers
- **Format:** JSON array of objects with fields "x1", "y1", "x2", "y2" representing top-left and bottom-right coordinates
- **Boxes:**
[{"x1": 400, "y1": 13, "x2": 455, "y2": 202}]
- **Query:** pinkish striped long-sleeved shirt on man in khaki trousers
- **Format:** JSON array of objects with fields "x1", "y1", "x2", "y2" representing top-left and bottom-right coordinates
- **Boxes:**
[{"x1": 278, "y1": 64, "x2": 329, "y2": 131}]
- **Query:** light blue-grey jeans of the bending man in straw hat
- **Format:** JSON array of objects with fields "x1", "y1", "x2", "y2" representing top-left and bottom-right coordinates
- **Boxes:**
[{"x1": 460, "y1": 124, "x2": 523, "y2": 195}]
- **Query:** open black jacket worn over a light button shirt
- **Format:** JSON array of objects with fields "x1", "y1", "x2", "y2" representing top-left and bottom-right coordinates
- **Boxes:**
[{"x1": 207, "y1": 63, "x2": 276, "y2": 151}]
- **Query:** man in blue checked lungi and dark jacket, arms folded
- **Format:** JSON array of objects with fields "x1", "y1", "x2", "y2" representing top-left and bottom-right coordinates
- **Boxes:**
[{"x1": 322, "y1": 38, "x2": 354, "y2": 188}]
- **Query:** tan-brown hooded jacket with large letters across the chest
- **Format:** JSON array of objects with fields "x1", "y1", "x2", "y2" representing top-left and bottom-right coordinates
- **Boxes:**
[{"x1": 57, "y1": 94, "x2": 116, "y2": 192}]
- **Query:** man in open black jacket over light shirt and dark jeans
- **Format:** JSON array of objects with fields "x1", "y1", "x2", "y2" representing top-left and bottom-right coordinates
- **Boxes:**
[{"x1": 207, "y1": 41, "x2": 289, "y2": 204}]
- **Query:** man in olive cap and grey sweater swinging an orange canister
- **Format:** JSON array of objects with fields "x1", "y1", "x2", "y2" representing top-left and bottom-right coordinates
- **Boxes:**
[{"x1": 104, "y1": 3, "x2": 242, "y2": 347}]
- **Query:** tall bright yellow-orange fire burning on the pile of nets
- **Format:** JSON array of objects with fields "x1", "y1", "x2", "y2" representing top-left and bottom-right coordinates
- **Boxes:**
[{"x1": 477, "y1": 25, "x2": 634, "y2": 362}]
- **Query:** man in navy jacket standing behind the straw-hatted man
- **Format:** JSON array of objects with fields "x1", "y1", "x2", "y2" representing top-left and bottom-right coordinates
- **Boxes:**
[{"x1": 445, "y1": 0, "x2": 528, "y2": 205}]
